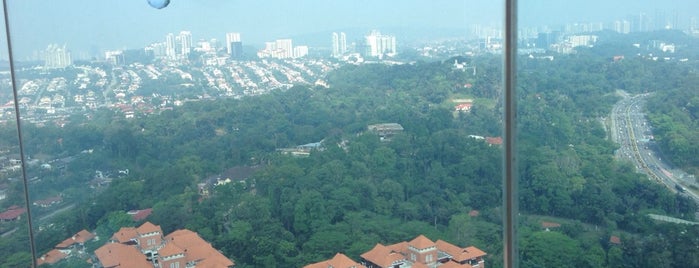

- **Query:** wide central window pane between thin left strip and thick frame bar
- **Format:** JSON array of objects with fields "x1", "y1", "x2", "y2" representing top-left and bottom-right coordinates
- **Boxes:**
[{"x1": 3, "y1": 0, "x2": 503, "y2": 267}]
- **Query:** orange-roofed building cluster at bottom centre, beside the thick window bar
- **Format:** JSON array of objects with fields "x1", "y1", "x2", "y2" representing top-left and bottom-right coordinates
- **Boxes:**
[{"x1": 304, "y1": 235, "x2": 486, "y2": 268}]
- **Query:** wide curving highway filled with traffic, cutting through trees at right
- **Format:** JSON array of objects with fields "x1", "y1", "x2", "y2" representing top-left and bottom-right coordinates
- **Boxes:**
[{"x1": 609, "y1": 93, "x2": 699, "y2": 203}]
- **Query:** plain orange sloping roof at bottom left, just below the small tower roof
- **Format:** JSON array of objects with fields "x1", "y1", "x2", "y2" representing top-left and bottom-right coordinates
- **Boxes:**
[{"x1": 95, "y1": 243, "x2": 153, "y2": 268}]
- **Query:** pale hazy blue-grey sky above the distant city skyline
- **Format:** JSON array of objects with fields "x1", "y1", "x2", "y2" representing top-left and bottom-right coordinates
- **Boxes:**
[{"x1": 3, "y1": 0, "x2": 699, "y2": 58}]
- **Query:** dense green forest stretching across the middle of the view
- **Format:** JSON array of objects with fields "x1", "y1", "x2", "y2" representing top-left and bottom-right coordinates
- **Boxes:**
[{"x1": 0, "y1": 47, "x2": 699, "y2": 267}]
